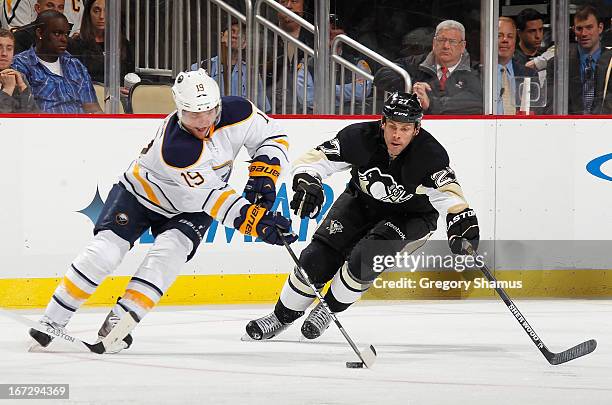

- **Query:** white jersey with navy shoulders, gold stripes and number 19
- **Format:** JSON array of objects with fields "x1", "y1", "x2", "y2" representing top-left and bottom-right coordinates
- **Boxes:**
[{"x1": 120, "y1": 97, "x2": 289, "y2": 227}]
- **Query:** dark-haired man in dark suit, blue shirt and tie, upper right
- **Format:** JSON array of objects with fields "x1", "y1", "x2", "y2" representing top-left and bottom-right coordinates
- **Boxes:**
[{"x1": 546, "y1": 5, "x2": 603, "y2": 114}]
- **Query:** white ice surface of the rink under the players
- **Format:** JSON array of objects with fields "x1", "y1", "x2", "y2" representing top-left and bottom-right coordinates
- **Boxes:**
[{"x1": 0, "y1": 300, "x2": 612, "y2": 405}]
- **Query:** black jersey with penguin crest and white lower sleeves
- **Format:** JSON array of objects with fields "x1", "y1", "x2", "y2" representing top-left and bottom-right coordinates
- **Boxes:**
[{"x1": 293, "y1": 121, "x2": 468, "y2": 217}]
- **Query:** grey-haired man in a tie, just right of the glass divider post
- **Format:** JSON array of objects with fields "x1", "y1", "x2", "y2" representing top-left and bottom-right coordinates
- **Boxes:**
[{"x1": 497, "y1": 17, "x2": 537, "y2": 115}]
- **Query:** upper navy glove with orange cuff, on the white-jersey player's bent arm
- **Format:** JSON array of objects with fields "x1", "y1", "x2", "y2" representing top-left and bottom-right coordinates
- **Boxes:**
[{"x1": 244, "y1": 156, "x2": 280, "y2": 210}]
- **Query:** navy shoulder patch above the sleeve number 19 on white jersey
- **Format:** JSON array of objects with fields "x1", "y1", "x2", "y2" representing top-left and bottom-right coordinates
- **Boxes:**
[{"x1": 162, "y1": 114, "x2": 204, "y2": 169}]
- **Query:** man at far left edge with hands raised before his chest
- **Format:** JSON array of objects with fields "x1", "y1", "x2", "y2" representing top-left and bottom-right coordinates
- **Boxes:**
[{"x1": 0, "y1": 28, "x2": 38, "y2": 113}]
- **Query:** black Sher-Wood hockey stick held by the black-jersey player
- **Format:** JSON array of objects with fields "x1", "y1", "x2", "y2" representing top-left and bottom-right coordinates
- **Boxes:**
[{"x1": 462, "y1": 239, "x2": 597, "y2": 366}]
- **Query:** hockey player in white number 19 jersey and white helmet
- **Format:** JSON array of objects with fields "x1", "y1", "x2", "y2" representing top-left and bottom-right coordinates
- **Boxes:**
[{"x1": 30, "y1": 69, "x2": 297, "y2": 351}]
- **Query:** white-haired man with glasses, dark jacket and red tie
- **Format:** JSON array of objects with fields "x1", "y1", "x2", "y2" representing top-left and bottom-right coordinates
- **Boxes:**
[{"x1": 374, "y1": 20, "x2": 483, "y2": 114}]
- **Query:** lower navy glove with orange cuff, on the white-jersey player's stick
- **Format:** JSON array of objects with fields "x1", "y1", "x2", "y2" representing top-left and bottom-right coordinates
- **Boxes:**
[{"x1": 234, "y1": 204, "x2": 298, "y2": 245}]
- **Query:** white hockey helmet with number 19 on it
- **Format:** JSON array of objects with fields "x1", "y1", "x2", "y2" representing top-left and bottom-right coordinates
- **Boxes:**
[{"x1": 172, "y1": 69, "x2": 221, "y2": 122}]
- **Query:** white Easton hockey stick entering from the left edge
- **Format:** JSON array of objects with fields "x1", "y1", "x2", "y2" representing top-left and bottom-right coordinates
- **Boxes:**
[{"x1": 0, "y1": 308, "x2": 138, "y2": 354}]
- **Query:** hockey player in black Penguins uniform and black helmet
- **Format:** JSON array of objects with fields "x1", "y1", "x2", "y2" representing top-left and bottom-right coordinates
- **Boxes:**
[{"x1": 246, "y1": 93, "x2": 479, "y2": 340}]
